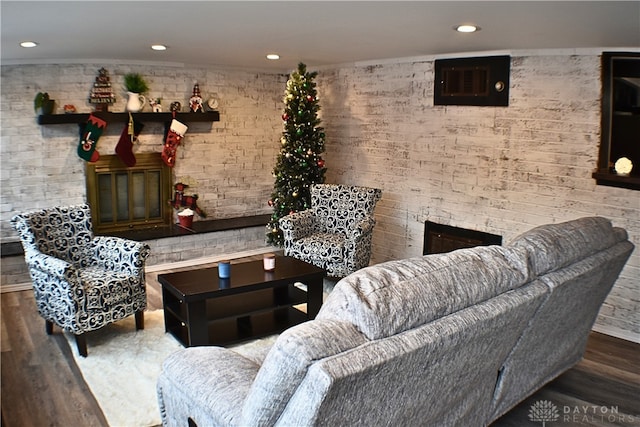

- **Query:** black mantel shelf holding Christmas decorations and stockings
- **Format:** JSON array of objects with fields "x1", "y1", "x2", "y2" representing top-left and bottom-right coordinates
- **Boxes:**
[{"x1": 38, "y1": 111, "x2": 220, "y2": 125}]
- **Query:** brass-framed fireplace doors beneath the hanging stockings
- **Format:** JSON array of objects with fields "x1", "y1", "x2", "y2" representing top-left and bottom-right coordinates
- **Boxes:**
[{"x1": 86, "y1": 153, "x2": 171, "y2": 234}]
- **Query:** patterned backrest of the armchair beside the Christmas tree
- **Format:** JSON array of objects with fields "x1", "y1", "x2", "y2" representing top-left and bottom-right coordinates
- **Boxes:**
[{"x1": 311, "y1": 184, "x2": 382, "y2": 234}]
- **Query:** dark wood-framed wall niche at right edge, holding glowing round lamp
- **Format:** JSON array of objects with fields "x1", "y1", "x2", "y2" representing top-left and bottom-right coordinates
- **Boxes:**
[{"x1": 593, "y1": 52, "x2": 640, "y2": 190}]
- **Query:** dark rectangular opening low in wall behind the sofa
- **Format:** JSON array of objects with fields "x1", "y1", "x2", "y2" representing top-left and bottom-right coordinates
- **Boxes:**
[{"x1": 422, "y1": 221, "x2": 502, "y2": 255}]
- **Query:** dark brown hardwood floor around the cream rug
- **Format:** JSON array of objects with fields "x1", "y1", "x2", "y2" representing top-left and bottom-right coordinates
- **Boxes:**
[{"x1": 0, "y1": 260, "x2": 640, "y2": 427}]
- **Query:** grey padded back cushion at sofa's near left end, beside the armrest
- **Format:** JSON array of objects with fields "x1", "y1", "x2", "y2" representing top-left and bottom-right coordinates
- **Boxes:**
[{"x1": 239, "y1": 320, "x2": 366, "y2": 426}]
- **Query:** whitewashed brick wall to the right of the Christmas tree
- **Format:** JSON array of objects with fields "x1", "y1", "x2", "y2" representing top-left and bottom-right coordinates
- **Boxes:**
[{"x1": 318, "y1": 54, "x2": 640, "y2": 341}]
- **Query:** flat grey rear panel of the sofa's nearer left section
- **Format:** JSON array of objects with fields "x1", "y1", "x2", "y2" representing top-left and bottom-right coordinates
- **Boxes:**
[{"x1": 276, "y1": 282, "x2": 546, "y2": 426}]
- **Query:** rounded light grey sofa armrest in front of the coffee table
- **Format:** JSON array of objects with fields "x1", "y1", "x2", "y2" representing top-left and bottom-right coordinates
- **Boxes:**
[{"x1": 157, "y1": 347, "x2": 260, "y2": 426}]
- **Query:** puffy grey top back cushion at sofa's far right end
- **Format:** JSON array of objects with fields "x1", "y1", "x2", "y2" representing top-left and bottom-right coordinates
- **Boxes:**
[{"x1": 508, "y1": 217, "x2": 627, "y2": 275}]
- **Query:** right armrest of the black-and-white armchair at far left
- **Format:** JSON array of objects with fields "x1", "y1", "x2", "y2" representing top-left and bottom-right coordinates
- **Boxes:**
[{"x1": 92, "y1": 236, "x2": 151, "y2": 275}]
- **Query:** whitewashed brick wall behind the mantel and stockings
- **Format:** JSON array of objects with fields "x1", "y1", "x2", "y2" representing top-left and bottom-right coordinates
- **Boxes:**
[{"x1": 0, "y1": 64, "x2": 287, "y2": 241}]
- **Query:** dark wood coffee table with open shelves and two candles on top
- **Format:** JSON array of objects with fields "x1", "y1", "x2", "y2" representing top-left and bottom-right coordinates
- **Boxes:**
[{"x1": 158, "y1": 256, "x2": 325, "y2": 347}]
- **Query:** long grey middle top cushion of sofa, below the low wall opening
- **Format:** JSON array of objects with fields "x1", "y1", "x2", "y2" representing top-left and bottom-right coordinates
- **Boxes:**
[{"x1": 317, "y1": 246, "x2": 529, "y2": 340}]
